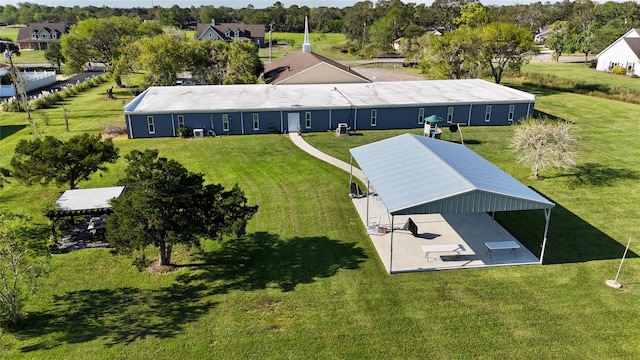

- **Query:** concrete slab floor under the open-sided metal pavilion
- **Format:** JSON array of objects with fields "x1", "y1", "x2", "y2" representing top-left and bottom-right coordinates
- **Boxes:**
[{"x1": 353, "y1": 195, "x2": 540, "y2": 273}]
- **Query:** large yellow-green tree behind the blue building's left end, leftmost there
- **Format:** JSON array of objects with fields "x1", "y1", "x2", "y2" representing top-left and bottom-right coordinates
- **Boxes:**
[{"x1": 61, "y1": 16, "x2": 162, "y2": 86}]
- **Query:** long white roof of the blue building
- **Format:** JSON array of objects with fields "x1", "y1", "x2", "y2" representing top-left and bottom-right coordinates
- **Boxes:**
[{"x1": 124, "y1": 79, "x2": 535, "y2": 114}]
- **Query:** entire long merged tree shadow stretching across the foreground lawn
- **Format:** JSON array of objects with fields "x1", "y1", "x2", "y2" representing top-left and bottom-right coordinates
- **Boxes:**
[{"x1": 14, "y1": 232, "x2": 367, "y2": 352}]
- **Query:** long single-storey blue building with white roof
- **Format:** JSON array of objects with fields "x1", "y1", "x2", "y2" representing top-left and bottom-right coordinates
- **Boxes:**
[{"x1": 124, "y1": 79, "x2": 535, "y2": 138}]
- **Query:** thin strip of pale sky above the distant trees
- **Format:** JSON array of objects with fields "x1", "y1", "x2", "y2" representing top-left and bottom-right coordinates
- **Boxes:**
[{"x1": 0, "y1": 0, "x2": 536, "y2": 9}]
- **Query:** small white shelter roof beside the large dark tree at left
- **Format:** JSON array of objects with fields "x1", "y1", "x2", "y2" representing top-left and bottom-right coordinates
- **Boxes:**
[{"x1": 57, "y1": 186, "x2": 124, "y2": 211}]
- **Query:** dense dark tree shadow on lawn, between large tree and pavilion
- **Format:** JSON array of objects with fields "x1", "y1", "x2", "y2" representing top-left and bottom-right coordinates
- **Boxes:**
[{"x1": 178, "y1": 232, "x2": 367, "y2": 293}]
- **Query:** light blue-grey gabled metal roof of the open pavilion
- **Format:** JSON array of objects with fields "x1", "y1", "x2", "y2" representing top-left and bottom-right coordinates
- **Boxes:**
[{"x1": 350, "y1": 134, "x2": 555, "y2": 215}]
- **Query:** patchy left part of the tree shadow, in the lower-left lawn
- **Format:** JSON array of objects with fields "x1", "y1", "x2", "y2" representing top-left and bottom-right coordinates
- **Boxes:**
[{"x1": 16, "y1": 284, "x2": 216, "y2": 352}]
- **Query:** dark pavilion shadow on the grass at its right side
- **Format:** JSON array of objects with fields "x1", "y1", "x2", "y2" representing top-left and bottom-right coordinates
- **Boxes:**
[{"x1": 496, "y1": 200, "x2": 638, "y2": 264}]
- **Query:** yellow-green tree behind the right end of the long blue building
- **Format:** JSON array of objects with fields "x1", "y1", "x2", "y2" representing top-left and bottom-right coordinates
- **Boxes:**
[{"x1": 480, "y1": 22, "x2": 535, "y2": 84}]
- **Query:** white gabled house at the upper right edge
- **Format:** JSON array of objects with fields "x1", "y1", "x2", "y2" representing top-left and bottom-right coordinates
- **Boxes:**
[{"x1": 596, "y1": 28, "x2": 640, "y2": 76}]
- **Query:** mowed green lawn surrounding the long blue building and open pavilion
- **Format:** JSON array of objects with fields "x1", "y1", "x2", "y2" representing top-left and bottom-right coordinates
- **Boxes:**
[{"x1": 0, "y1": 65, "x2": 640, "y2": 359}]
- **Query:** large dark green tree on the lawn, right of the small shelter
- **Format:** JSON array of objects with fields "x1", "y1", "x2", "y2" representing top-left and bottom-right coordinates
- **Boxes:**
[{"x1": 107, "y1": 150, "x2": 258, "y2": 265}]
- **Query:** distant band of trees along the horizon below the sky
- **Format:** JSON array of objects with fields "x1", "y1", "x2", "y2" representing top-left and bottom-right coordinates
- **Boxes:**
[{"x1": 0, "y1": 0, "x2": 640, "y2": 37}]
